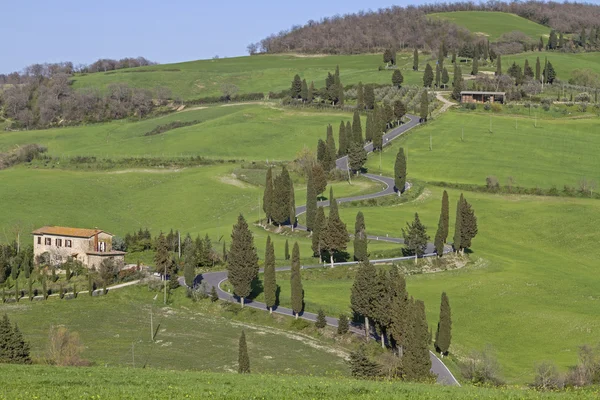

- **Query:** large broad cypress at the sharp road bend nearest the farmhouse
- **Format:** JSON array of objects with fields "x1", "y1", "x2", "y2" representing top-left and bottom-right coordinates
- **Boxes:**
[{"x1": 227, "y1": 214, "x2": 258, "y2": 308}]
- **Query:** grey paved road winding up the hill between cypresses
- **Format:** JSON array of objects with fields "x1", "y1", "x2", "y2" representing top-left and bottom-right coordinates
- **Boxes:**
[{"x1": 188, "y1": 114, "x2": 460, "y2": 386}]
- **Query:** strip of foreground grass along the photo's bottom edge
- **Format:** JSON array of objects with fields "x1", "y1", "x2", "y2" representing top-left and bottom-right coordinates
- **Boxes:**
[{"x1": 0, "y1": 359, "x2": 598, "y2": 400}]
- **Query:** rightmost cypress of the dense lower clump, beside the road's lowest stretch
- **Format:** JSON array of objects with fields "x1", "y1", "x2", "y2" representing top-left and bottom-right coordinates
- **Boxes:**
[{"x1": 402, "y1": 300, "x2": 431, "y2": 381}]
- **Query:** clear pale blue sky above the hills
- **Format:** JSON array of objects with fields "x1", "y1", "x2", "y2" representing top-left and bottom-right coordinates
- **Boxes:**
[{"x1": 0, "y1": 0, "x2": 426, "y2": 73}]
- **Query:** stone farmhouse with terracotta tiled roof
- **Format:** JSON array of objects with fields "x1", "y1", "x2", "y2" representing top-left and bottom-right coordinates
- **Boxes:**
[{"x1": 32, "y1": 226, "x2": 125, "y2": 268}]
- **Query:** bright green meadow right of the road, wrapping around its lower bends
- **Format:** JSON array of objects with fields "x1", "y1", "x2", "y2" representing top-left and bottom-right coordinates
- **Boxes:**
[{"x1": 238, "y1": 187, "x2": 600, "y2": 383}]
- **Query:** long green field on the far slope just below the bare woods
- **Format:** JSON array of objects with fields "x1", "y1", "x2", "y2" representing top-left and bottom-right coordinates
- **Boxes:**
[{"x1": 74, "y1": 53, "x2": 426, "y2": 100}]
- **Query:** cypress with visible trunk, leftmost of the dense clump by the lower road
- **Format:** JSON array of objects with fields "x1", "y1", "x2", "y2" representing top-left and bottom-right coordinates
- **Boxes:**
[{"x1": 350, "y1": 259, "x2": 379, "y2": 341}]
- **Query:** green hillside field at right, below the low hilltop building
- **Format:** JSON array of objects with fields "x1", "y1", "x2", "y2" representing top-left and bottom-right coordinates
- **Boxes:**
[{"x1": 367, "y1": 111, "x2": 600, "y2": 189}]
